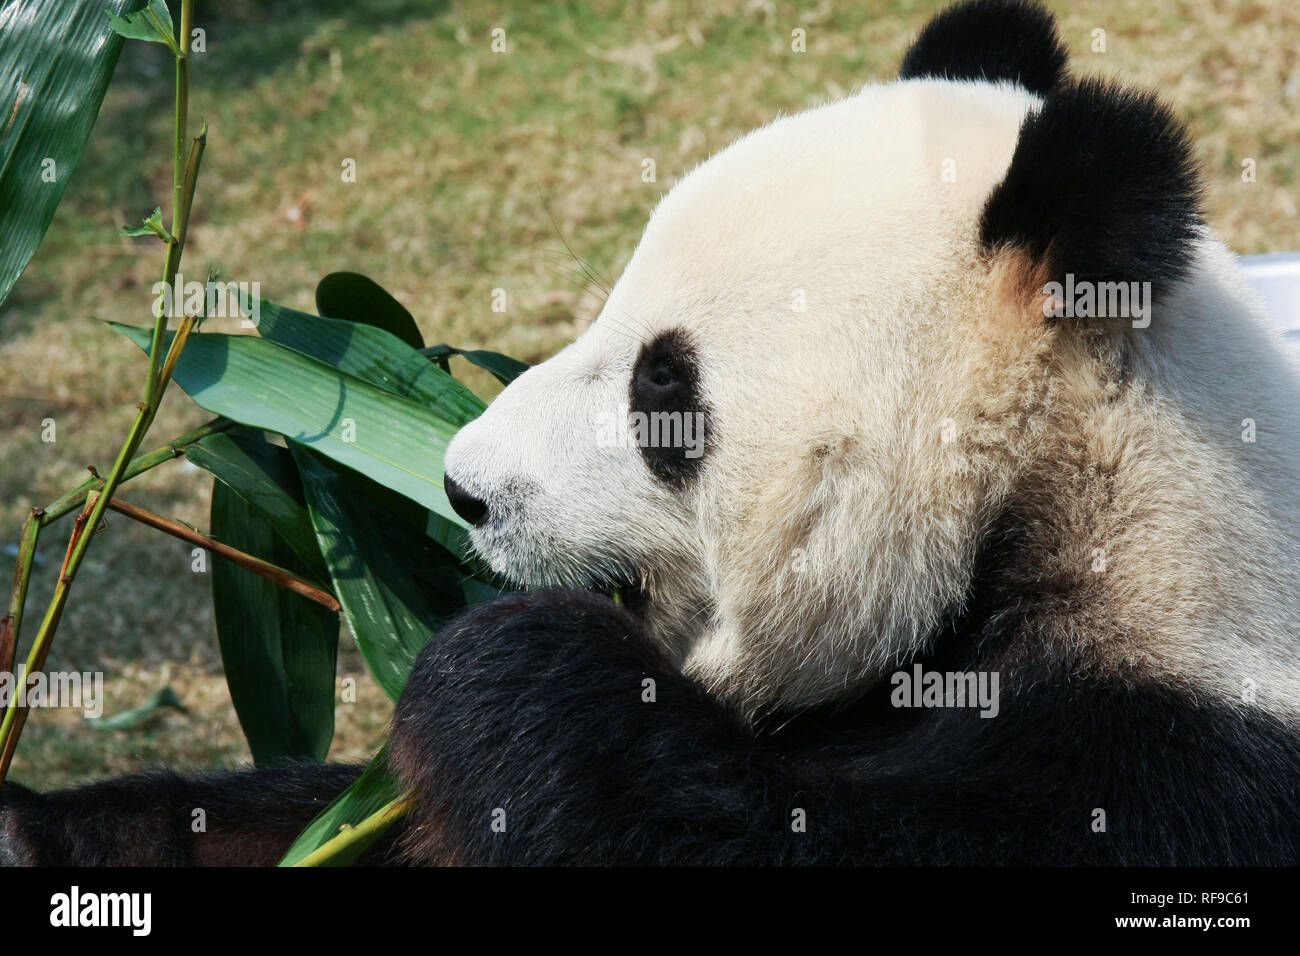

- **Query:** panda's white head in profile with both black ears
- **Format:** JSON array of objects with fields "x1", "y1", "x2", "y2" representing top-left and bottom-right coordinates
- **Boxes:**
[{"x1": 446, "y1": 0, "x2": 1201, "y2": 710}]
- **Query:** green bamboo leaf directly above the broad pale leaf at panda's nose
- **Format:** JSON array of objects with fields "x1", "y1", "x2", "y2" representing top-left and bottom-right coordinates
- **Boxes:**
[{"x1": 250, "y1": 299, "x2": 486, "y2": 427}]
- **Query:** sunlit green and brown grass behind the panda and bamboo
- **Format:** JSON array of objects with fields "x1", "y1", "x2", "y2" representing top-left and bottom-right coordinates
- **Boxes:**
[{"x1": 0, "y1": 0, "x2": 1300, "y2": 788}]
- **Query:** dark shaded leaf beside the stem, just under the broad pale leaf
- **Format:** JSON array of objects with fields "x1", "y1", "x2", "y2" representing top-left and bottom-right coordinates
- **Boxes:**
[{"x1": 185, "y1": 428, "x2": 329, "y2": 585}]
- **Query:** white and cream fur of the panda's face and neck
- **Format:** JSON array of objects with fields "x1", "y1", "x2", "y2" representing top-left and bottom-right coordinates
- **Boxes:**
[{"x1": 446, "y1": 81, "x2": 1300, "y2": 710}]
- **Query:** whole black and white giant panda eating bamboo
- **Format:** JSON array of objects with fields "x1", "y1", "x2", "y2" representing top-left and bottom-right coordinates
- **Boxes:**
[{"x1": 0, "y1": 0, "x2": 1300, "y2": 865}]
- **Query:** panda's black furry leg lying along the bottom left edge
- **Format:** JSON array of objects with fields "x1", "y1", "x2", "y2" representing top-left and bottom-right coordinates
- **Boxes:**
[{"x1": 0, "y1": 763, "x2": 395, "y2": 866}]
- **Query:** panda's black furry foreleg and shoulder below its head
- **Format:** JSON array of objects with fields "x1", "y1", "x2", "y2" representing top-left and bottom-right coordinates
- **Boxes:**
[{"x1": 393, "y1": 592, "x2": 1300, "y2": 865}]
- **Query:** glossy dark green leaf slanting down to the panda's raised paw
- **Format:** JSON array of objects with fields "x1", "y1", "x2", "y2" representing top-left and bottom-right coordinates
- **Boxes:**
[{"x1": 291, "y1": 445, "x2": 465, "y2": 700}]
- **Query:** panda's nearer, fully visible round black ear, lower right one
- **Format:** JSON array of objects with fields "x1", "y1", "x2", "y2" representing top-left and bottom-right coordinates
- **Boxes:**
[{"x1": 979, "y1": 81, "x2": 1203, "y2": 314}]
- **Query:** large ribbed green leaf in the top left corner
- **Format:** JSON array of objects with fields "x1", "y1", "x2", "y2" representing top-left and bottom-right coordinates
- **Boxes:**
[{"x1": 0, "y1": 0, "x2": 143, "y2": 303}]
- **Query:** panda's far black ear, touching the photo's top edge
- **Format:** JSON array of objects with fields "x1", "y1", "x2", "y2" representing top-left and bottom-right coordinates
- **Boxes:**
[{"x1": 898, "y1": 0, "x2": 1066, "y2": 96}]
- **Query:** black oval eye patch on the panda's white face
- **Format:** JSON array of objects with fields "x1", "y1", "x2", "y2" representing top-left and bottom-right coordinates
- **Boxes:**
[{"x1": 628, "y1": 329, "x2": 707, "y2": 485}]
